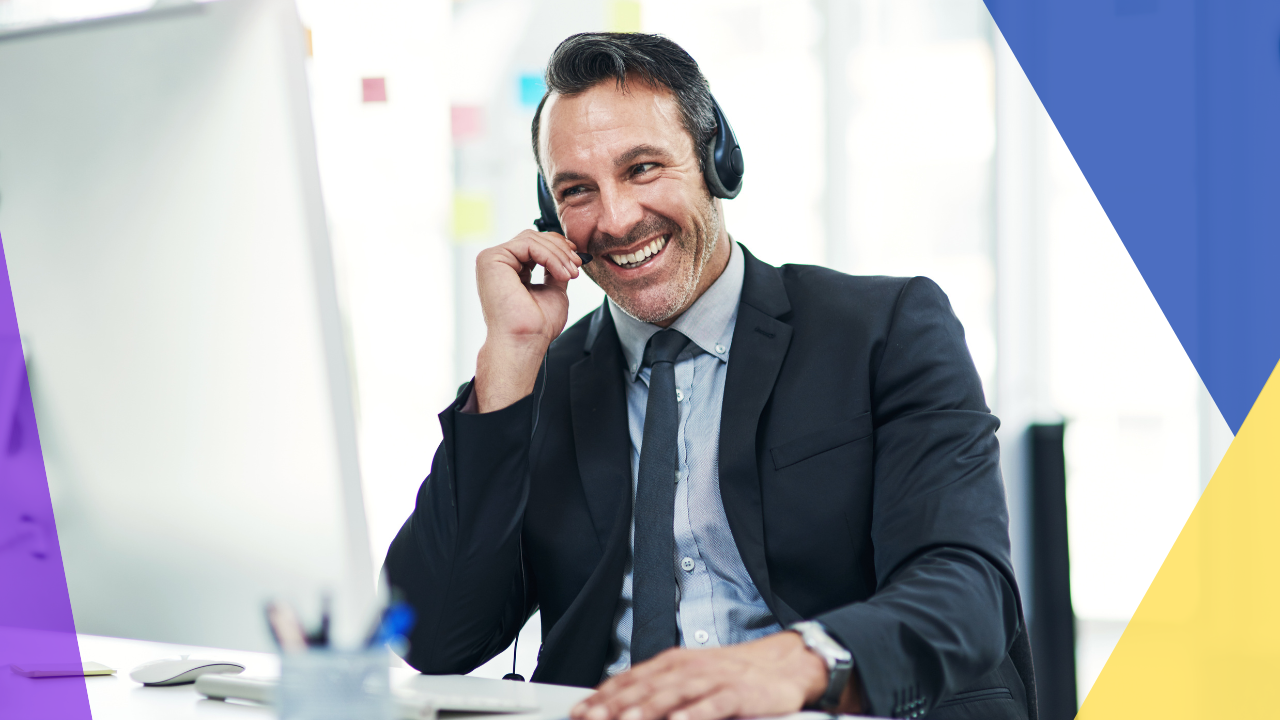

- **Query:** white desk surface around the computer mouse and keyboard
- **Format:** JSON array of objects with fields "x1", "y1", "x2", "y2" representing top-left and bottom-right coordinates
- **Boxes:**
[{"x1": 79, "y1": 635, "x2": 591, "y2": 720}]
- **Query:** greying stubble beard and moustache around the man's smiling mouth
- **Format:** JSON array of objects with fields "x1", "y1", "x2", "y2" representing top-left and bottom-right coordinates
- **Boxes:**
[{"x1": 582, "y1": 195, "x2": 721, "y2": 324}]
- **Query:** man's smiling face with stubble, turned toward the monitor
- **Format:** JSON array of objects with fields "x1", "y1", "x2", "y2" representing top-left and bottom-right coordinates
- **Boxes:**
[{"x1": 539, "y1": 79, "x2": 730, "y2": 327}]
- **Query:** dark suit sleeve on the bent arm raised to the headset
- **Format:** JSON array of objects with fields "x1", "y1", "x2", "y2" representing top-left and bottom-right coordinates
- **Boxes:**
[{"x1": 383, "y1": 384, "x2": 536, "y2": 674}]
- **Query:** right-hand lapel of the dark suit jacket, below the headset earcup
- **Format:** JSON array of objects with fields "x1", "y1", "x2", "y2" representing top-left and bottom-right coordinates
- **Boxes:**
[{"x1": 719, "y1": 249, "x2": 800, "y2": 624}]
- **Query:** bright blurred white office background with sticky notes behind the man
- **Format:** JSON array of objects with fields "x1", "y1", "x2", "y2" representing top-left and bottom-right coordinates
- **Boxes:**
[{"x1": 0, "y1": 0, "x2": 1231, "y2": 700}]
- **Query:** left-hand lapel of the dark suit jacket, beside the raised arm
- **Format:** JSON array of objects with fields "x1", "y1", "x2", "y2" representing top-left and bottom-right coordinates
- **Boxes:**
[{"x1": 568, "y1": 306, "x2": 631, "y2": 550}]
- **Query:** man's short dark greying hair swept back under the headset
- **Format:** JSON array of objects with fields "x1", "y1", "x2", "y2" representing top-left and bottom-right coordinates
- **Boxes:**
[{"x1": 532, "y1": 32, "x2": 716, "y2": 172}]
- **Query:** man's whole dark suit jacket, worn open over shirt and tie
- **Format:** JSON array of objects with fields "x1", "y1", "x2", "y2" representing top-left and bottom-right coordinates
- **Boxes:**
[{"x1": 385, "y1": 243, "x2": 1036, "y2": 717}]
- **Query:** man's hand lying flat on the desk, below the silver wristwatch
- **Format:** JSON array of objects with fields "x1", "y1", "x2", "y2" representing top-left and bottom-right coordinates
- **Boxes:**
[{"x1": 570, "y1": 632, "x2": 861, "y2": 720}]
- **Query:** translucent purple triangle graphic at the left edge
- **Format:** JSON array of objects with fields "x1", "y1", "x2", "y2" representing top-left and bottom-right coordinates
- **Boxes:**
[{"x1": 0, "y1": 233, "x2": 91, "y2": 720}]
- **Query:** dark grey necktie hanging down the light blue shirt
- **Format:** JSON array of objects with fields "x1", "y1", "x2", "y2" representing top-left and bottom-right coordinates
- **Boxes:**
[{"x1": 631, "y1": 331, "x2": 689, "y2": 666}]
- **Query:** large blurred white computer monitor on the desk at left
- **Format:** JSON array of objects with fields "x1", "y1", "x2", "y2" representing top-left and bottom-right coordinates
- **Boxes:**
[{"x1": 0, "y1": 0, "x2": 374, "y2": 650}]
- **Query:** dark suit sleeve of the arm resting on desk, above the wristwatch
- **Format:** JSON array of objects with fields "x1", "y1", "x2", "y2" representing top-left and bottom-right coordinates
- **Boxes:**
[{"x1": 818, "y1": 272, "x2": 1021, "y2": 716}]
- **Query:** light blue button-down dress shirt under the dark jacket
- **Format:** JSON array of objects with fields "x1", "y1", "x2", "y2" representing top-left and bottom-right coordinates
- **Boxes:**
[{"x1": 605, "y1": 241, "x2": 782, "y2": 676}]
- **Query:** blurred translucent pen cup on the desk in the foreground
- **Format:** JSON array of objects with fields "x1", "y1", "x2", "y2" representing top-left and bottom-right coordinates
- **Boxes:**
[{"x1": 275, "y1": 648, "x2": 392, "y2": 720}]
